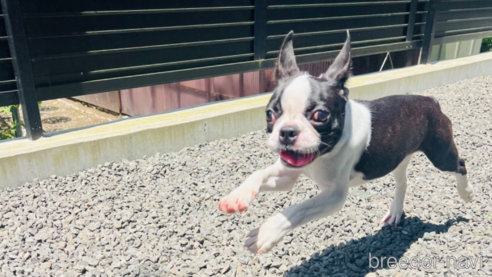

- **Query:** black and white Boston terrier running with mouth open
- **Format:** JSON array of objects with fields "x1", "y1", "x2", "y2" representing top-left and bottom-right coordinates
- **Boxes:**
[{"x1": 219, "y1": 32, "x2": 473, "y2": 253}]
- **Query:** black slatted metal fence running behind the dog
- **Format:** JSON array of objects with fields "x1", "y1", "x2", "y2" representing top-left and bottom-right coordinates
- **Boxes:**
[{"x1": 0, "y1": 0, "x2": 492, "y2": 139}]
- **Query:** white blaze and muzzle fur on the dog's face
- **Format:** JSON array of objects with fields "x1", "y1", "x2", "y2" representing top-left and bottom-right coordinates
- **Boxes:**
[{"x1": 268, "y1": 74, "x2": 319, "y2": 152}]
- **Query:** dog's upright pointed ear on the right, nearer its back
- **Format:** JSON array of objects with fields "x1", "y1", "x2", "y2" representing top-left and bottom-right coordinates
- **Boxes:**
[{"x1": 325, "y1": 30, "x2": 352, "y2": 88}]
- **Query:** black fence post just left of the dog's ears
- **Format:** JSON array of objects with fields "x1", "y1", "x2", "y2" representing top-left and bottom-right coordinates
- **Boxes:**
[{"x1": 254, "y1": 0, "x2": 267, "y2": 60}]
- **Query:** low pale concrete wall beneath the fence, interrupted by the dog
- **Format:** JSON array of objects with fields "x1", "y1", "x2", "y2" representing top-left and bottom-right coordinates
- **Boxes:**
[{"x1": 0, "y1": 53, "x2": 492, "y2": 189}]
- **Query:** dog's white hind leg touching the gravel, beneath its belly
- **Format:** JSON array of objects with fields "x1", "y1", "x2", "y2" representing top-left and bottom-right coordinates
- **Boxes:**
[{"x1": 380, "y1": 154, "x2": 412, "y2": 226}]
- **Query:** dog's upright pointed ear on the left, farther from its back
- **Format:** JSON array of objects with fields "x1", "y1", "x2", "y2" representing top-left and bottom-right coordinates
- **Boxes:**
[{"x1": 275, "y1": 31, "x2": 300, "y2": 81}]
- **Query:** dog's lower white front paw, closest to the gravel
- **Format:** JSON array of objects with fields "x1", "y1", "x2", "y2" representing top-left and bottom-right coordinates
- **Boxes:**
[{"x1": 244, "y1": 214, "x2": 291, "y2": 254}]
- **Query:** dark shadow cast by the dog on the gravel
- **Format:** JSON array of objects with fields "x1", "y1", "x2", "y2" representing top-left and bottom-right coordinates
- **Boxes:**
[{"x1": 284, "y1": 217, "x2": 469, "y2": 277}]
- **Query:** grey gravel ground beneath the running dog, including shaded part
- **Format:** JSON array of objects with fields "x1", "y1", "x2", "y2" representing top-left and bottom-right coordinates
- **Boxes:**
[{"x1": 0, "y1": 76, "x2": 492, "y2": 277}]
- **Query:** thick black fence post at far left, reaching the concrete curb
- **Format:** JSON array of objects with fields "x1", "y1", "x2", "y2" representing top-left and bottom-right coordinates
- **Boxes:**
[{"x1": 1, "y1": 0, "x2": 43, "y2": 140}]
